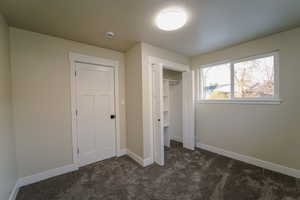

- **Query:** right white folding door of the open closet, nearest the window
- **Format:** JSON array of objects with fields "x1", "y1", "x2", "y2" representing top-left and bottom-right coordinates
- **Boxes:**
[{"x1": 182, "y1": 71, "x2": 196, "y2": 150}]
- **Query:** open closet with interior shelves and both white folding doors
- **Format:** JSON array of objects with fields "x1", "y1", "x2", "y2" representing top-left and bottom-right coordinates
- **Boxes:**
[{"x1": 150, "y1": 59, "x2": 195, "y2": 165}]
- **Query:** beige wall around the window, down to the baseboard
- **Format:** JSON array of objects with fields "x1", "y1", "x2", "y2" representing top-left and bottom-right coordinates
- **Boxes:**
[{"x1": 192, "y1": 28, "x2": 300, "y2": 169}]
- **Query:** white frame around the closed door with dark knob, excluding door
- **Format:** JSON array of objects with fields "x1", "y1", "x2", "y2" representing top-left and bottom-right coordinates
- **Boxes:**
[{"x1": 69, "y1": 52, "x2": 121, "y2": 167}]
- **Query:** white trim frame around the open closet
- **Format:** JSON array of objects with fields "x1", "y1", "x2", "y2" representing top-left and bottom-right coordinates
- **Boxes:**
[{"x1": 147, "y1": 56, "x2": 191, "y2": 162}]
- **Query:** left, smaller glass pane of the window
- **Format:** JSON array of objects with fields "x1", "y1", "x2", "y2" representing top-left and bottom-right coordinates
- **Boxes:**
[{"x1": 202, "y1": 63, "x2": 231, "y2": 99}]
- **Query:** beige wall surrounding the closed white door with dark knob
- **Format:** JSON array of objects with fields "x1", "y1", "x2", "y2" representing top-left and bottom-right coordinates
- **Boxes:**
[{"x1": 10, "y1": 28, "x2": 126, "y2": 177}]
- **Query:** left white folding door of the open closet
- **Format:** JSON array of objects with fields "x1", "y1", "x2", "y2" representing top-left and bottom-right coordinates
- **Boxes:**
[{"x1": 152, "y1": 65, "x2": 165, "y2": 165}]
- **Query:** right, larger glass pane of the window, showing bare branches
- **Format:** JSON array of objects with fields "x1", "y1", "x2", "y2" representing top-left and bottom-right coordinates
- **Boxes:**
[{"x1": 234, "y1": 56, "x2": 274, "y2": 98}]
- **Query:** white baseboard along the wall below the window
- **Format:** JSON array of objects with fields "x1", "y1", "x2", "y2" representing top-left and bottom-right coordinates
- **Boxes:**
[{"x1": 197, "y1": 143, "x2": 300, "y2": 178}]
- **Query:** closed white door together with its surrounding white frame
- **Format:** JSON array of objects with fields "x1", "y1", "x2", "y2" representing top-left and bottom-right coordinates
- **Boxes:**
[{"x1": 70, "y1": 53, "x2": 120, "y2": 167}]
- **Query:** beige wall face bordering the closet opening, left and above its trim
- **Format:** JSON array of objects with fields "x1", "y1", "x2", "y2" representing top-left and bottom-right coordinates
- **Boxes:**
[{"x1": 142, "y1": 43, "x2": 190, "y2": 158}]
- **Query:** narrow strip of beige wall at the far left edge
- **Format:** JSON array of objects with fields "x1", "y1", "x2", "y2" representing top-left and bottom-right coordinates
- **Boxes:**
[{"x1": 0, "y1": 14, "x2": 17, "y2": 200}]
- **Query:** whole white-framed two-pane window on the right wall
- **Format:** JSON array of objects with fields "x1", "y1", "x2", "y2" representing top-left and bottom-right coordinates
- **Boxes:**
[{"x1": 200, "y1": 53, "x2": 279, "y2": 102}]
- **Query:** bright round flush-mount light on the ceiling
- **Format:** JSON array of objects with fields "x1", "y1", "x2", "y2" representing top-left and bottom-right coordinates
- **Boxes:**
[{"x1": 155, "y1": 8, "x2": 187, "y2": 31}]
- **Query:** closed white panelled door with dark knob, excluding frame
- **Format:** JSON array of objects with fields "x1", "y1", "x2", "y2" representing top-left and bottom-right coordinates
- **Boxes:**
[{"x1": 76, "y1": 63, "x2": 116, "y2": 166}]
